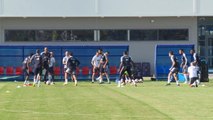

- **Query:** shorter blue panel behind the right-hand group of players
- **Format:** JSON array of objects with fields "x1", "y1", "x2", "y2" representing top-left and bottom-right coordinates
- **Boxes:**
[{"x1": 155, "y1": 45, "x2": 194, "y2": 80}]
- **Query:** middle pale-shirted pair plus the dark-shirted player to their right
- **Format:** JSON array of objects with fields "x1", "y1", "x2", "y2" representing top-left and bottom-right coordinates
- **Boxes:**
[{"x1": 91, "y1": 49, "x2": 141, "y2": 87}]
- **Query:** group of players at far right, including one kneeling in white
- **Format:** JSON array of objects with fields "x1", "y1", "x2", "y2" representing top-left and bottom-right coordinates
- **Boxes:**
[{"x1": 166, "y1": 49, "x2": 201, "y2": 87}]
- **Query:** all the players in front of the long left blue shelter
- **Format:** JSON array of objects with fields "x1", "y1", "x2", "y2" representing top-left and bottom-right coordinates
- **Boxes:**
[{"x1": 23, "y1": 47, "x2": 141, "y2": 87}]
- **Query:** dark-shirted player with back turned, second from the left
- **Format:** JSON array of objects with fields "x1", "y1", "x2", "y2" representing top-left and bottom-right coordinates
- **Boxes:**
[{"x1": 30, "y1": 49, "x2": 42, "y2": 87}]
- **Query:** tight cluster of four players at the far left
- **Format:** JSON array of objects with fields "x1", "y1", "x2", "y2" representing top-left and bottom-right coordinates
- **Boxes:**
[{"x1": 23, "y1": 47, "x2": 55, "y2": 87}]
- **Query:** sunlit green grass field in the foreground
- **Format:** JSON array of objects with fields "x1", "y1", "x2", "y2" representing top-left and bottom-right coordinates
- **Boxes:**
[{"x1": 0, "y1": 81, "x2": 213, "y2": 120}]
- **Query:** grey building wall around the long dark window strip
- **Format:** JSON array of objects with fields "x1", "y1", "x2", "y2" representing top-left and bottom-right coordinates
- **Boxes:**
[{"x1": 0, "y1": 17, "x2": 197, "y2": 73}]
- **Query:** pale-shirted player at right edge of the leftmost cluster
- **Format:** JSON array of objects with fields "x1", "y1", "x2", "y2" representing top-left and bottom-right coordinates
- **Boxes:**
[{"x1": 47, "y1": 52, "x2": 55, "y2": 85}]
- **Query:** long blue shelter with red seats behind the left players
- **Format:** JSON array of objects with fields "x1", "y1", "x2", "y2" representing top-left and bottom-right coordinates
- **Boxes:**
[{"x1": 0, "y1": 45, "x2": 129, "y2": 80}]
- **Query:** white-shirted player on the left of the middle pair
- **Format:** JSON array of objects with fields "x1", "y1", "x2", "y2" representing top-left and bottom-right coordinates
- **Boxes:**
[{"x1": 91, "y1": 51, "x2": 102, "y2": 83}]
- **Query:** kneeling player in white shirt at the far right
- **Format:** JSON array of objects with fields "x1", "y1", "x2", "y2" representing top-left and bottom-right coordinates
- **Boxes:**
[{"x1": 188, "y1": 62, "x2": 199, "y2": 87}]
